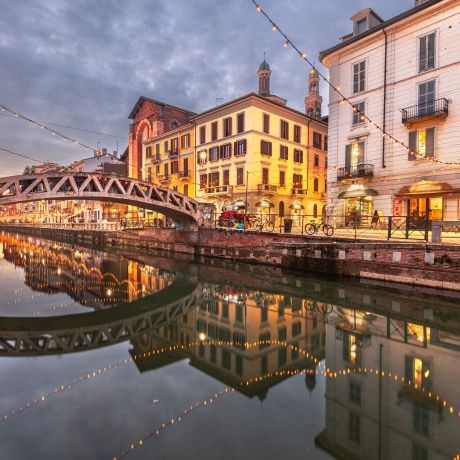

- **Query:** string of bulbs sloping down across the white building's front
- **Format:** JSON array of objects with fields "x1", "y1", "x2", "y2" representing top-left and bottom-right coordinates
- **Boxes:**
[{"x1": 250, "y1": 0, "x2": 460, "y2": 166}]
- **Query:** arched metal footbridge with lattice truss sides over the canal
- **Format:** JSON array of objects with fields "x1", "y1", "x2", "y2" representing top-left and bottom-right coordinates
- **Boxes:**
[{"x1": 0, "y1": 172, "x2": 201, "y2": 226}]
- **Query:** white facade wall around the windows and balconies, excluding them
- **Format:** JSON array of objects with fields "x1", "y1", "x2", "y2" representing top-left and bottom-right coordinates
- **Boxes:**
[{"x1": 323, "y1": 0, "x2": 460, "y2": 220}]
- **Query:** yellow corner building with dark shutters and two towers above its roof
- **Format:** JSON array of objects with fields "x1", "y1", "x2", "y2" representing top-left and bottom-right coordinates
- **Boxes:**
[{"x1": 194, "y1": 60, "x2": 327, "y2": 222}]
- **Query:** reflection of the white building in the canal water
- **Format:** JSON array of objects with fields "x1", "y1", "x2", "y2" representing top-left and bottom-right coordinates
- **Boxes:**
[{"x1": 316, "y1": 304, "x2": 460, "y2": 460}]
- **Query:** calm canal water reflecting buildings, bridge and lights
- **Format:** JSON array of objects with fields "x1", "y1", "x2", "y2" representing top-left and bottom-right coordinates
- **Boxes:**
[{"x1": 0, "y1": 233, "x2": 460, "y2": 460}]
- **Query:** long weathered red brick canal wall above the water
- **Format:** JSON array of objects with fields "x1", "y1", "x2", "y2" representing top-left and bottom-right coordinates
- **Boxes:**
[{"x1": 3, "y1": 226, "x2": 460, "y2": 291}]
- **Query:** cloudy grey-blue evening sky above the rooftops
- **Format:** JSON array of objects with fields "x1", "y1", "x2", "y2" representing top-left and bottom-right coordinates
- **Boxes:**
[{"x1": 0, "y1": 0, "x2": 413, "y2": 176}]
